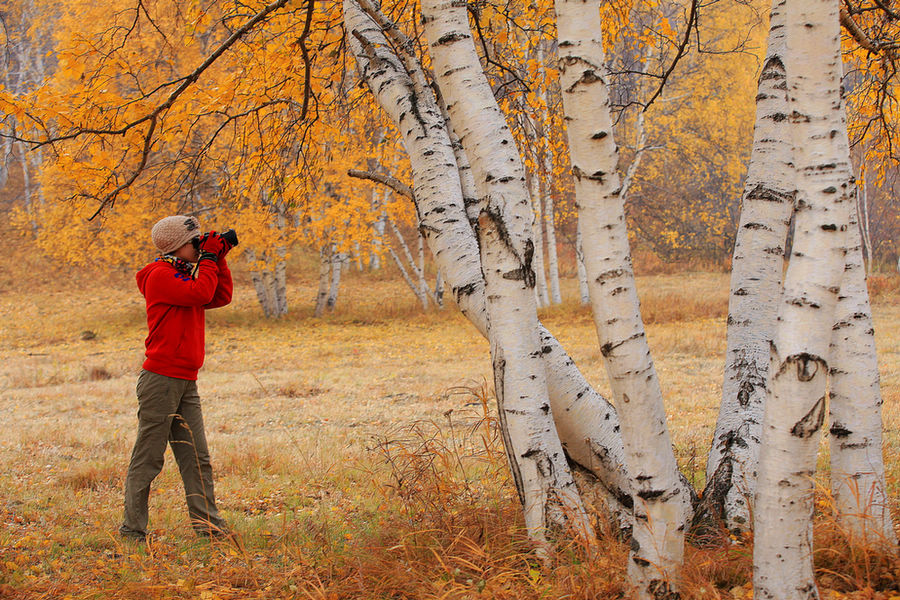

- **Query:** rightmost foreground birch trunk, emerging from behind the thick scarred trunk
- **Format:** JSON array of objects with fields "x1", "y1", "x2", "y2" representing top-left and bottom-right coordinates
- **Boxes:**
[{"x1": 828, "y1": 191, "x2": 897, "y2": 550}]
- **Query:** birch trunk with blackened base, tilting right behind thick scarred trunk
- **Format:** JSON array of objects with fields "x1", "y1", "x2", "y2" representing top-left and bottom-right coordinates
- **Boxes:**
[{"x1": 694, "y1": 0, "x2": 794, "y2": 534}]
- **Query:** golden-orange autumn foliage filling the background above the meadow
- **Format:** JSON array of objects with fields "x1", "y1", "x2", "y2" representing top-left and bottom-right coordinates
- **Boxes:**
[{"x1": 0, "y1": 0, "x2": 900, "y2": 278}]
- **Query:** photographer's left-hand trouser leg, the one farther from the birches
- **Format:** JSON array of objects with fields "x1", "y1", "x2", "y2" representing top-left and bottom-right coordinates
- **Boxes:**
[{"x1": 119, "y1": 371, "x2": 180, "y2": 539}]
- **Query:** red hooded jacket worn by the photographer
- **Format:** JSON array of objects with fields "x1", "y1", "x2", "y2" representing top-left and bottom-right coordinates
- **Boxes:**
[{"x1": 137, "y1": 258, "x2": 233, "y2": 380}]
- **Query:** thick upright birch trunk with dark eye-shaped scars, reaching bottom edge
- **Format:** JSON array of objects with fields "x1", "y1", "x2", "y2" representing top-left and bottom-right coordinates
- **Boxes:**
[{"x1": 753, "y1": 0, "x2": 853, "y2": 600}]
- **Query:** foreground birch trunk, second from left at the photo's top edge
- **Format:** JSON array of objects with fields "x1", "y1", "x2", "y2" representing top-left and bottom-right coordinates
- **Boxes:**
[{"x1": 422, "y1": 0, "x2": 593, "y2": 540}]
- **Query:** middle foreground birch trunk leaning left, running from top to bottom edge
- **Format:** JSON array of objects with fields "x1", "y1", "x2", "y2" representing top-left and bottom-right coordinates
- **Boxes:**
[{"x1": 555, "y1": 0, "x2": 690, "y2": 598}]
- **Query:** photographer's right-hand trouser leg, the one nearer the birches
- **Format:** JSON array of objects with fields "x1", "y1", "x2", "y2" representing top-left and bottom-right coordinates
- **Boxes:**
[{"x1": 169, "y1": 381, "x2": 228, "y2": 535}]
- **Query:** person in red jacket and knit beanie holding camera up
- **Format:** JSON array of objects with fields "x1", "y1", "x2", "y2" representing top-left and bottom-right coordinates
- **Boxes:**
[{"x1": 119, "y1": 216, "x2": 237, "y2": 541}]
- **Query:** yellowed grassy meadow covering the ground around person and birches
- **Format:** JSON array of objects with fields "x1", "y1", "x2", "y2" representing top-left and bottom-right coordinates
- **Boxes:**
[{"x1": 0, "y1": 246, "x2": 900, "y2": 600}]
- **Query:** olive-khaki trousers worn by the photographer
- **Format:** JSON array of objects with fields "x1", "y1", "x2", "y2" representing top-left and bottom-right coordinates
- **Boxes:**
[{"x1": 119, "y1": 370, "x2": 227, "y2": 537}]
